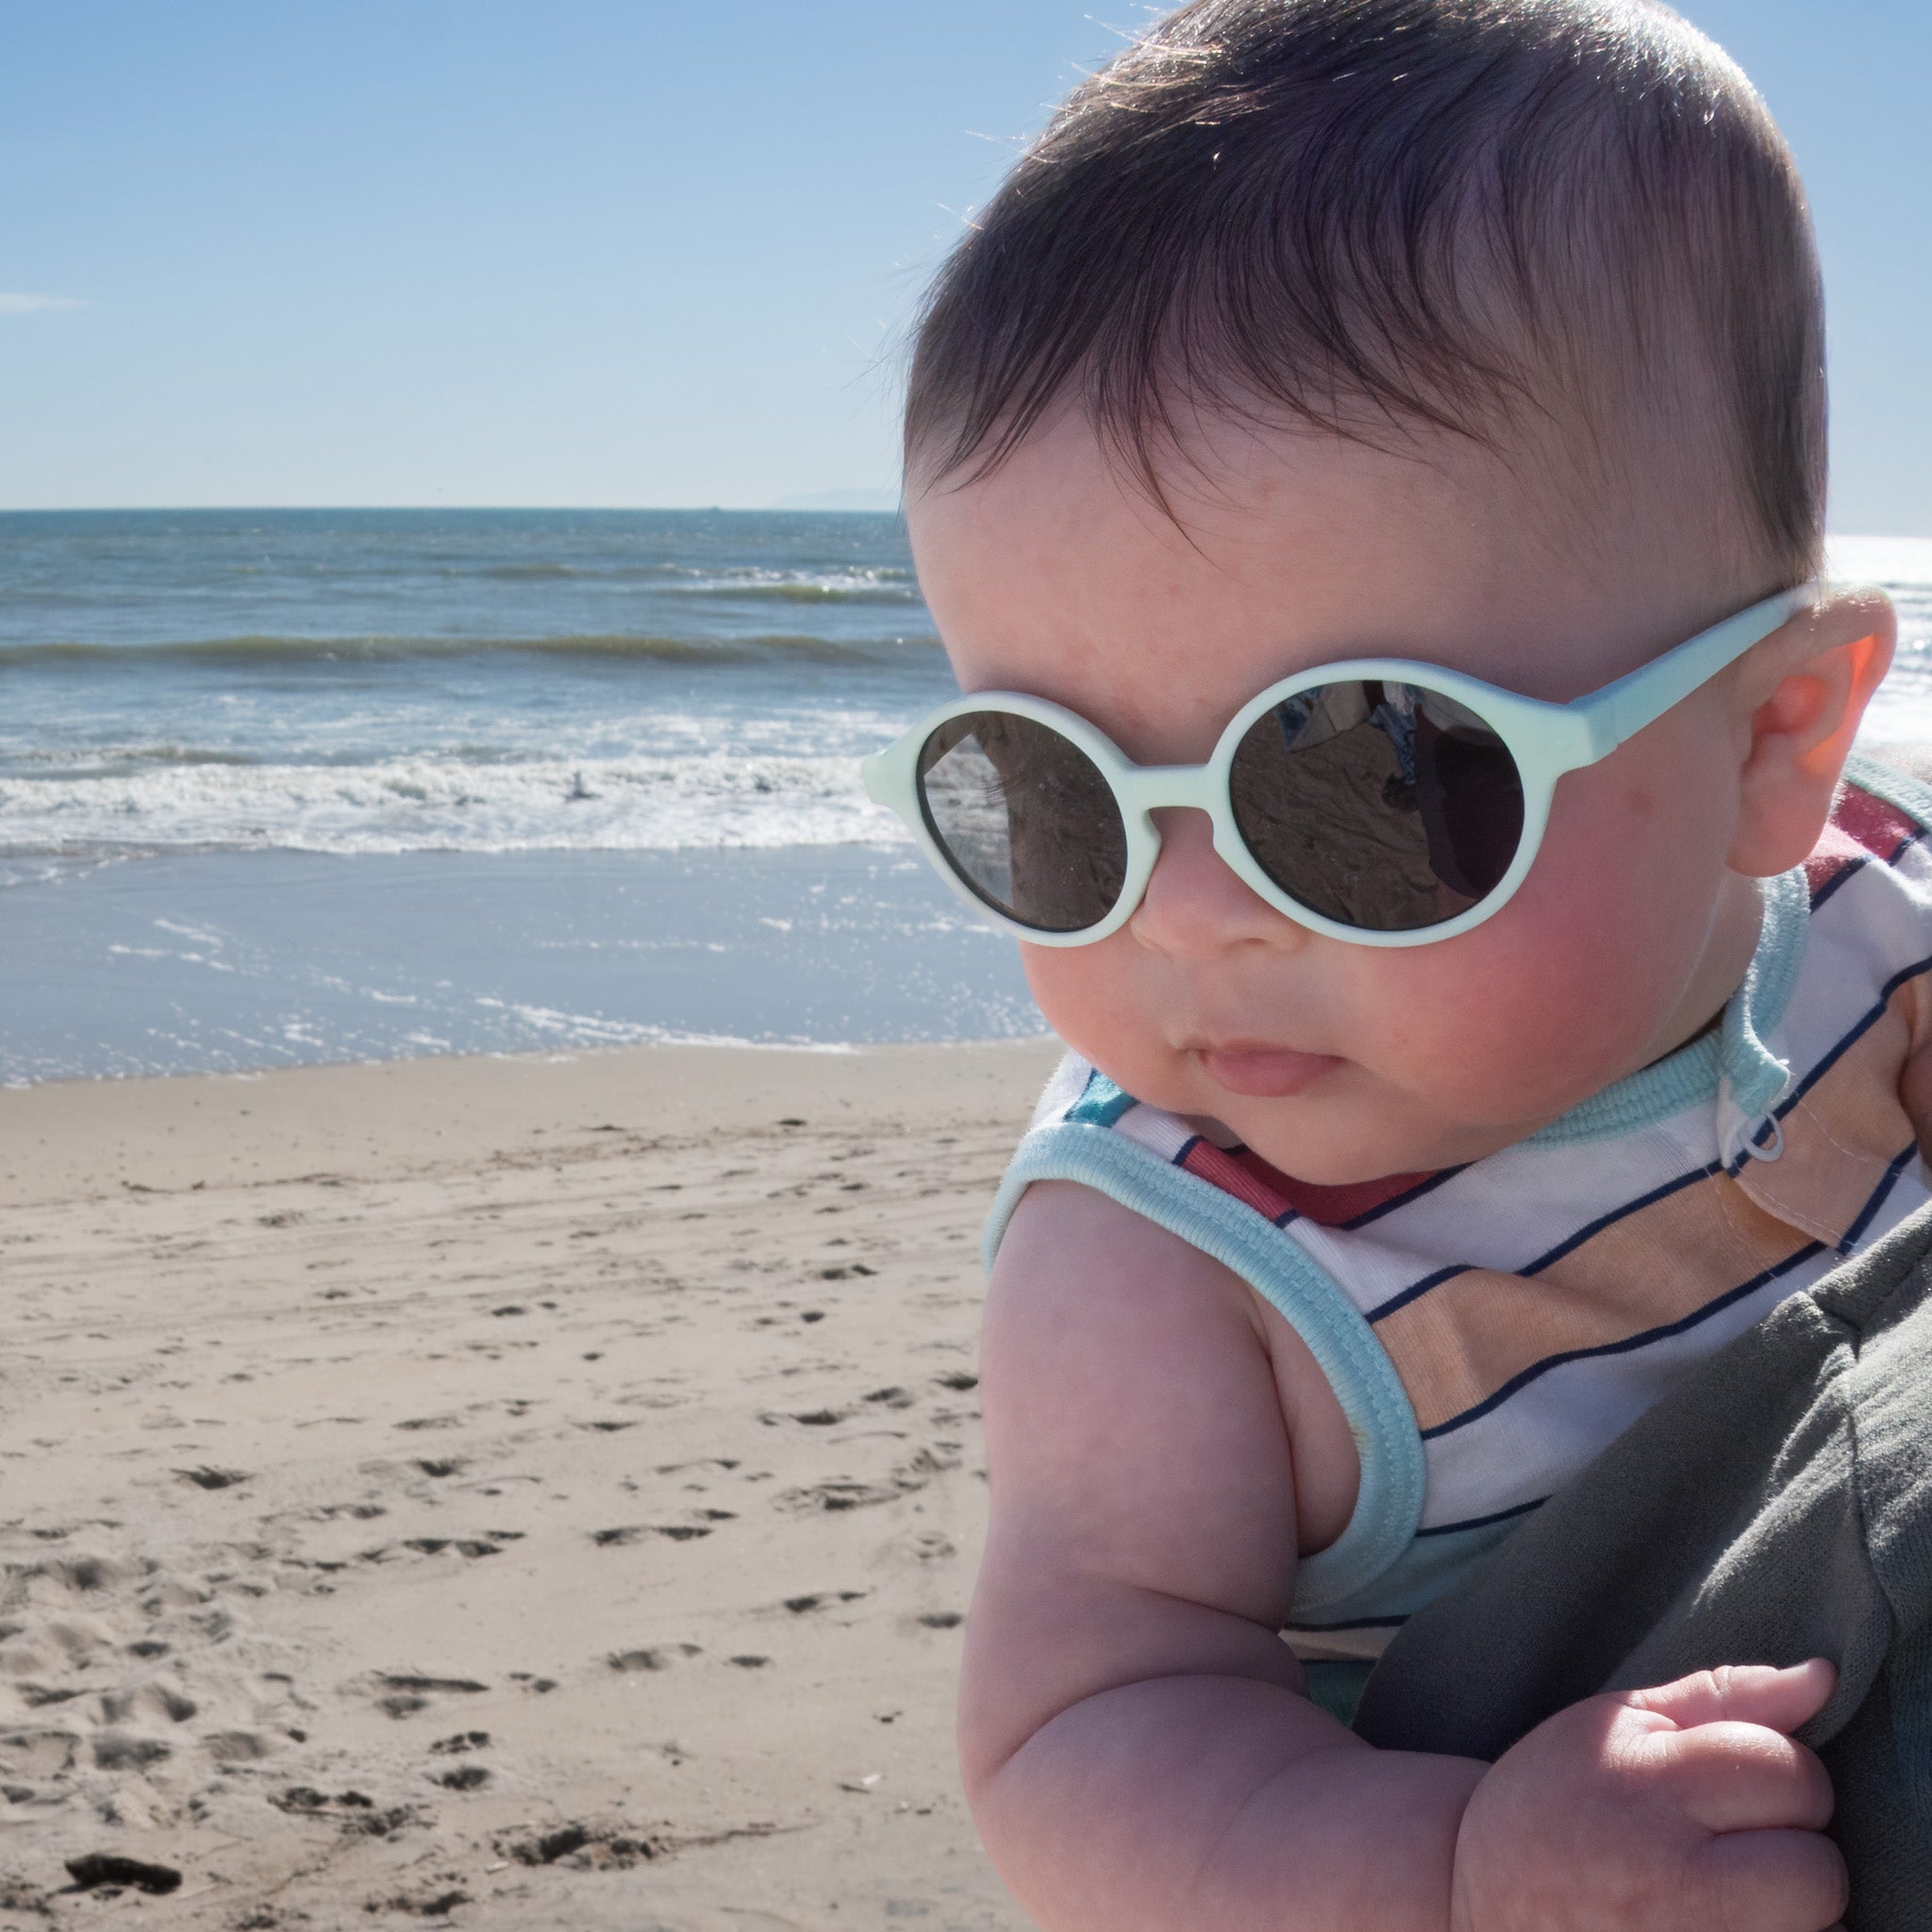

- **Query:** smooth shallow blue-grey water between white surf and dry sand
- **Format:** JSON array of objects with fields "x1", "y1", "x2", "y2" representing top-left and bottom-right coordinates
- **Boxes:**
[{"x1": 0, "y1": 846, "x2": 1041, "y2": 1082}]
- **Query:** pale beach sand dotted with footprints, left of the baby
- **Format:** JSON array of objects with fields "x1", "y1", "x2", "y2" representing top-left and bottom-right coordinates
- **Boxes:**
[{"x1": 0, "y1": 1043, "x2": 1053, "y2": 1932}]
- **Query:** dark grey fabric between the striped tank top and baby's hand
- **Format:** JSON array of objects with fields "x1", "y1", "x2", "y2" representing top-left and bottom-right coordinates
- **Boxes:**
[{"x1": 1355, "y1": 1209, "x2": 1932, "y2": 1932}]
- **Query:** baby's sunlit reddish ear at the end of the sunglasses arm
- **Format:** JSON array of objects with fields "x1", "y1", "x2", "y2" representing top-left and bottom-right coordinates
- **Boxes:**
[{"x1": 1725, "y1": 591, "x2": 1899, "y2": 879}]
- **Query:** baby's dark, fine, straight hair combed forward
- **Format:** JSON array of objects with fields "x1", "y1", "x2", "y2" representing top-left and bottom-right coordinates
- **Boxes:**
[{"x1": 907, "y1": 0, "x2": 1825, "y2": 581}]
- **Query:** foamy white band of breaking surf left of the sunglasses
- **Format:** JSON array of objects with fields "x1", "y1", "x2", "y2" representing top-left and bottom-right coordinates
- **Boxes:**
[{"x1": 0, "y1": 752, "x2": 907, "y2": 854}]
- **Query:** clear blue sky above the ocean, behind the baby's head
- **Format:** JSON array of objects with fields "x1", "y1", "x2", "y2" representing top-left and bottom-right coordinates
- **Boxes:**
[{"x1": 0, "y1": 0, "x2": 1932, "y2": 535}]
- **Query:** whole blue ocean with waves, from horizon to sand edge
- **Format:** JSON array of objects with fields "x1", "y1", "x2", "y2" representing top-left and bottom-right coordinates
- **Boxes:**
[{"x1": 0, "y1": 510, "x2": 1932, "y2": 1082}]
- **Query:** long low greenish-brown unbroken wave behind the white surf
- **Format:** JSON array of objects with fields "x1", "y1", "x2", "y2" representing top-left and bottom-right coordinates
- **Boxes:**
[{"x1": 0, "y1": 632, "x2": 939, "y2": 667}]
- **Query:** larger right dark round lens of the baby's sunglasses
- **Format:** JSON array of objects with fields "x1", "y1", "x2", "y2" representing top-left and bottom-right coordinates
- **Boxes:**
[{"x1": 1229, "y1": 678, "x2": 1523, "y2": 933}]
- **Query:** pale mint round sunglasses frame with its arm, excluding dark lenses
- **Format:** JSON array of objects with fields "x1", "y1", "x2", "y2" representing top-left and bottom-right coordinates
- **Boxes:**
[{"x1": 859, "y1": 581, "x2": 1822, "y2": 947}]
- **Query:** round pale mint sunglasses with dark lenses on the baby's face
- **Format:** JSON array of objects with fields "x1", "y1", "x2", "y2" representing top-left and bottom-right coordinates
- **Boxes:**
[{"x1": 859, "y1": 583, "x2": 1820, "y2": 947}]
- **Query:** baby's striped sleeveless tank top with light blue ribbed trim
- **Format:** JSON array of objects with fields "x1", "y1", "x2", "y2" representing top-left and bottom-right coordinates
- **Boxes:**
[{"x1": 985, "y1": 759, "x2": 1932, "y2": 1657}]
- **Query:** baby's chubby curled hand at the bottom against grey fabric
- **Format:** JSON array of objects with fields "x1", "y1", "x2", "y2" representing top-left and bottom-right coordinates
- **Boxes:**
[{"x1": 1451, "y1": 1657, "x2": 1847, "y2": 1932}]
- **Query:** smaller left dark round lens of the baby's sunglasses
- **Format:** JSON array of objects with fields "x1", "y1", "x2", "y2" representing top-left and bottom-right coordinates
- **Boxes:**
[{"x1": 920, "y1": 711, "x2": 1126, "y2": 933}]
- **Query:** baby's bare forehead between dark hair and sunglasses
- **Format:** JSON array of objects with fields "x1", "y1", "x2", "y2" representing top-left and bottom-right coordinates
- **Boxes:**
[{"x1": 908, "y1": 409, "x2": 1748, "y2": 761}]
